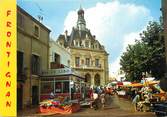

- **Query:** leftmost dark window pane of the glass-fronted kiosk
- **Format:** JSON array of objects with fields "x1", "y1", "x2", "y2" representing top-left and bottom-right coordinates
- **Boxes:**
[{"x1": 41, "y1": 82, "x2": 54, "y2": 94}]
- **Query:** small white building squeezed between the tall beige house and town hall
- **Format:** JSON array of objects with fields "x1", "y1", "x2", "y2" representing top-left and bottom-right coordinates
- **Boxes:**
[{"x1": 49, "y1": 40, "x2": 71, "y2": 69}]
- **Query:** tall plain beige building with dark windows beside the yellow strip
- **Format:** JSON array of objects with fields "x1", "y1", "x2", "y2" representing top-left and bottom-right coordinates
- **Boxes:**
[{"x1": 17, "y1": 7, "x2": 50, "y2": 109}]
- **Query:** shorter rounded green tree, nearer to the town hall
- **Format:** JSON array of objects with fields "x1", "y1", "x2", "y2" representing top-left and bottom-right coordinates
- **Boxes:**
[{"x1": 120, "y1": 41, "x2": 148, "y2": 81}]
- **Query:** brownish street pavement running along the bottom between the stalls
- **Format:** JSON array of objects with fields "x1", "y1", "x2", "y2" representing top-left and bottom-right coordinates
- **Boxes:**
[{"x1": 18, "y1": 96, "x2": 156, "y2": 117}]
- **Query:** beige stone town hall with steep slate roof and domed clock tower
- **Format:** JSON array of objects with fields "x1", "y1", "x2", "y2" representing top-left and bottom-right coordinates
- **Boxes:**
[{"x1": 57, "y1": 8, "x2": 109, "y2": 86}]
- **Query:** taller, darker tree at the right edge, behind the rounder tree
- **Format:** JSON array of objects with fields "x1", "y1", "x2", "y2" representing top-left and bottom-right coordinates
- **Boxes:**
[{"x1": 140, "y1": 22, "x2": 165, "y2": 79}]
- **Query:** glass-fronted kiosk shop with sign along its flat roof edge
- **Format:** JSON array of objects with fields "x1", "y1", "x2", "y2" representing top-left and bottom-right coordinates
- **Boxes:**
[{"x1": 40, "y1": 68, "x2": 85, "y2": 101}]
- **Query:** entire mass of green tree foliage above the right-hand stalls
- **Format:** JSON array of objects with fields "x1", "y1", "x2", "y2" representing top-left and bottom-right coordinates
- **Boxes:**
[{"x1": 120, "y1": 22, "x2": 165, "y2": 81}]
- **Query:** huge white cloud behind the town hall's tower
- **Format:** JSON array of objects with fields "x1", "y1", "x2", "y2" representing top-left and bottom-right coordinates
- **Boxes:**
[{"x1": 64, "y1": 1, "x2": 153, "y2": 76}]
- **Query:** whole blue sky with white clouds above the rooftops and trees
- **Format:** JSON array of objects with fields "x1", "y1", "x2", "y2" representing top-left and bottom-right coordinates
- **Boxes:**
[{"x1": 17, "y1": 0, "x2": 161, "y2": 75}]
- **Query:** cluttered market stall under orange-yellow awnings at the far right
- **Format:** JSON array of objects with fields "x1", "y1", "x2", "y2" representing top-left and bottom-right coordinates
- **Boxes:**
[{"x1": 132, "y1": 80, "x2": 166, "y2": 111}]
